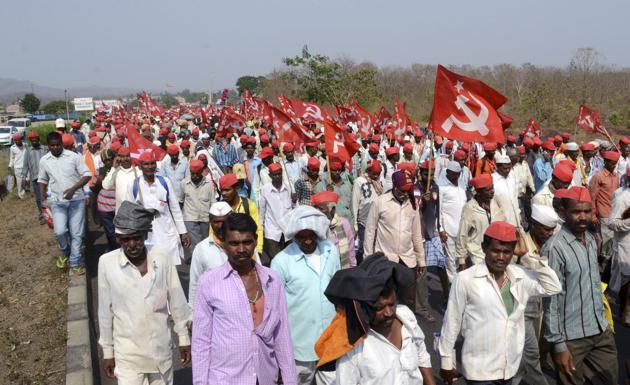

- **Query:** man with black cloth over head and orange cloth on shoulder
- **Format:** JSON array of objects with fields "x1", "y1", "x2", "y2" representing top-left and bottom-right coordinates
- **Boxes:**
[{"x1": 324, "y1": 253, "x2": 435, "y2": 385}]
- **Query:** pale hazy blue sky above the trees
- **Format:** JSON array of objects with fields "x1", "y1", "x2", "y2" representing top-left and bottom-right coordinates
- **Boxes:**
[{"x1": 0, "y1": 0, "x2": 630, "y2": 90}]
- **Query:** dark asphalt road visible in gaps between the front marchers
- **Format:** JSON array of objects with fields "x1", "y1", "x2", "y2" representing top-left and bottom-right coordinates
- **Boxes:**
[{"x1": 87, "y1": 221, "x2": 630, "y2": 385}]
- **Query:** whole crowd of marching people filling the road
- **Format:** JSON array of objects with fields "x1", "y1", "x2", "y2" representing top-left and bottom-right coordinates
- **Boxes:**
[{"x1": 4, "y1": 109, "x2": 630, "y2": 385}]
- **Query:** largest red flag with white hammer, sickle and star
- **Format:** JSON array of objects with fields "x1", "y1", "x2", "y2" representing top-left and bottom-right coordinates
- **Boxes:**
[{"x1": 429, "y1": 65, "x2": 507, "y2": 143}]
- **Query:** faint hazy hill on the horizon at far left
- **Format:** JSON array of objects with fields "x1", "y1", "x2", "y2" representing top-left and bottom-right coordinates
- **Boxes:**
[{"x1": 0, "y1": 78, "x2": 141, "y2": 104}]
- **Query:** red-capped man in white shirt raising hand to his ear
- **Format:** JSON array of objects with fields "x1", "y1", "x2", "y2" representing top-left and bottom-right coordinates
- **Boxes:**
[{"x1": 438, "y1": 221, "x2": 562, "y2": 385}]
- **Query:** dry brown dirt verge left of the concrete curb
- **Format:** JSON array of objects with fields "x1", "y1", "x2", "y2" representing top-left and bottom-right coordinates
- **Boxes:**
[{"x1": 0, "y1": 152, "x2": 68, "y2": 384}]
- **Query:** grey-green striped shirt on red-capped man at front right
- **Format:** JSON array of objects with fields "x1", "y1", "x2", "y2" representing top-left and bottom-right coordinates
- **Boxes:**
[{"x1": 540, "y1": 226, "x2": 608, "y2": 352}]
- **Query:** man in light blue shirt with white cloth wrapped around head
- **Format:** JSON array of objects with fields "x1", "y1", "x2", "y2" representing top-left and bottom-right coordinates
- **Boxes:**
[{"x1": 271, "y1": 206, "x2": 341, "y2": 385}]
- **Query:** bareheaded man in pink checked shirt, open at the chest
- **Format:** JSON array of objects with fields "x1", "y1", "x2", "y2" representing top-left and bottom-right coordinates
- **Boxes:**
[{"x1": 192, "y1": 214, "x2": 297, "y2": 385}]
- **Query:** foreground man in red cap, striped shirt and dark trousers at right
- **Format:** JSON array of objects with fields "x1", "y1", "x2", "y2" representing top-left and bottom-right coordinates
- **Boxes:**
[{"x1": 540, "y1": 187, "x2": 618, "y2": 384}]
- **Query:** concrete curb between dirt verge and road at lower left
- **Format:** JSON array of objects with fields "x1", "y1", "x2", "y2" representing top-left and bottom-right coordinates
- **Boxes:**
[{"x1": 66, "y1": 272, "x2": 94, "y2": 385}]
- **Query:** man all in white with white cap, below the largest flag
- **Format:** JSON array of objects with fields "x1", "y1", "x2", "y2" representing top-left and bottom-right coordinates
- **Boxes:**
[{"x1": 438, "y1": 161, "x2": 466, "y2": 282}]
